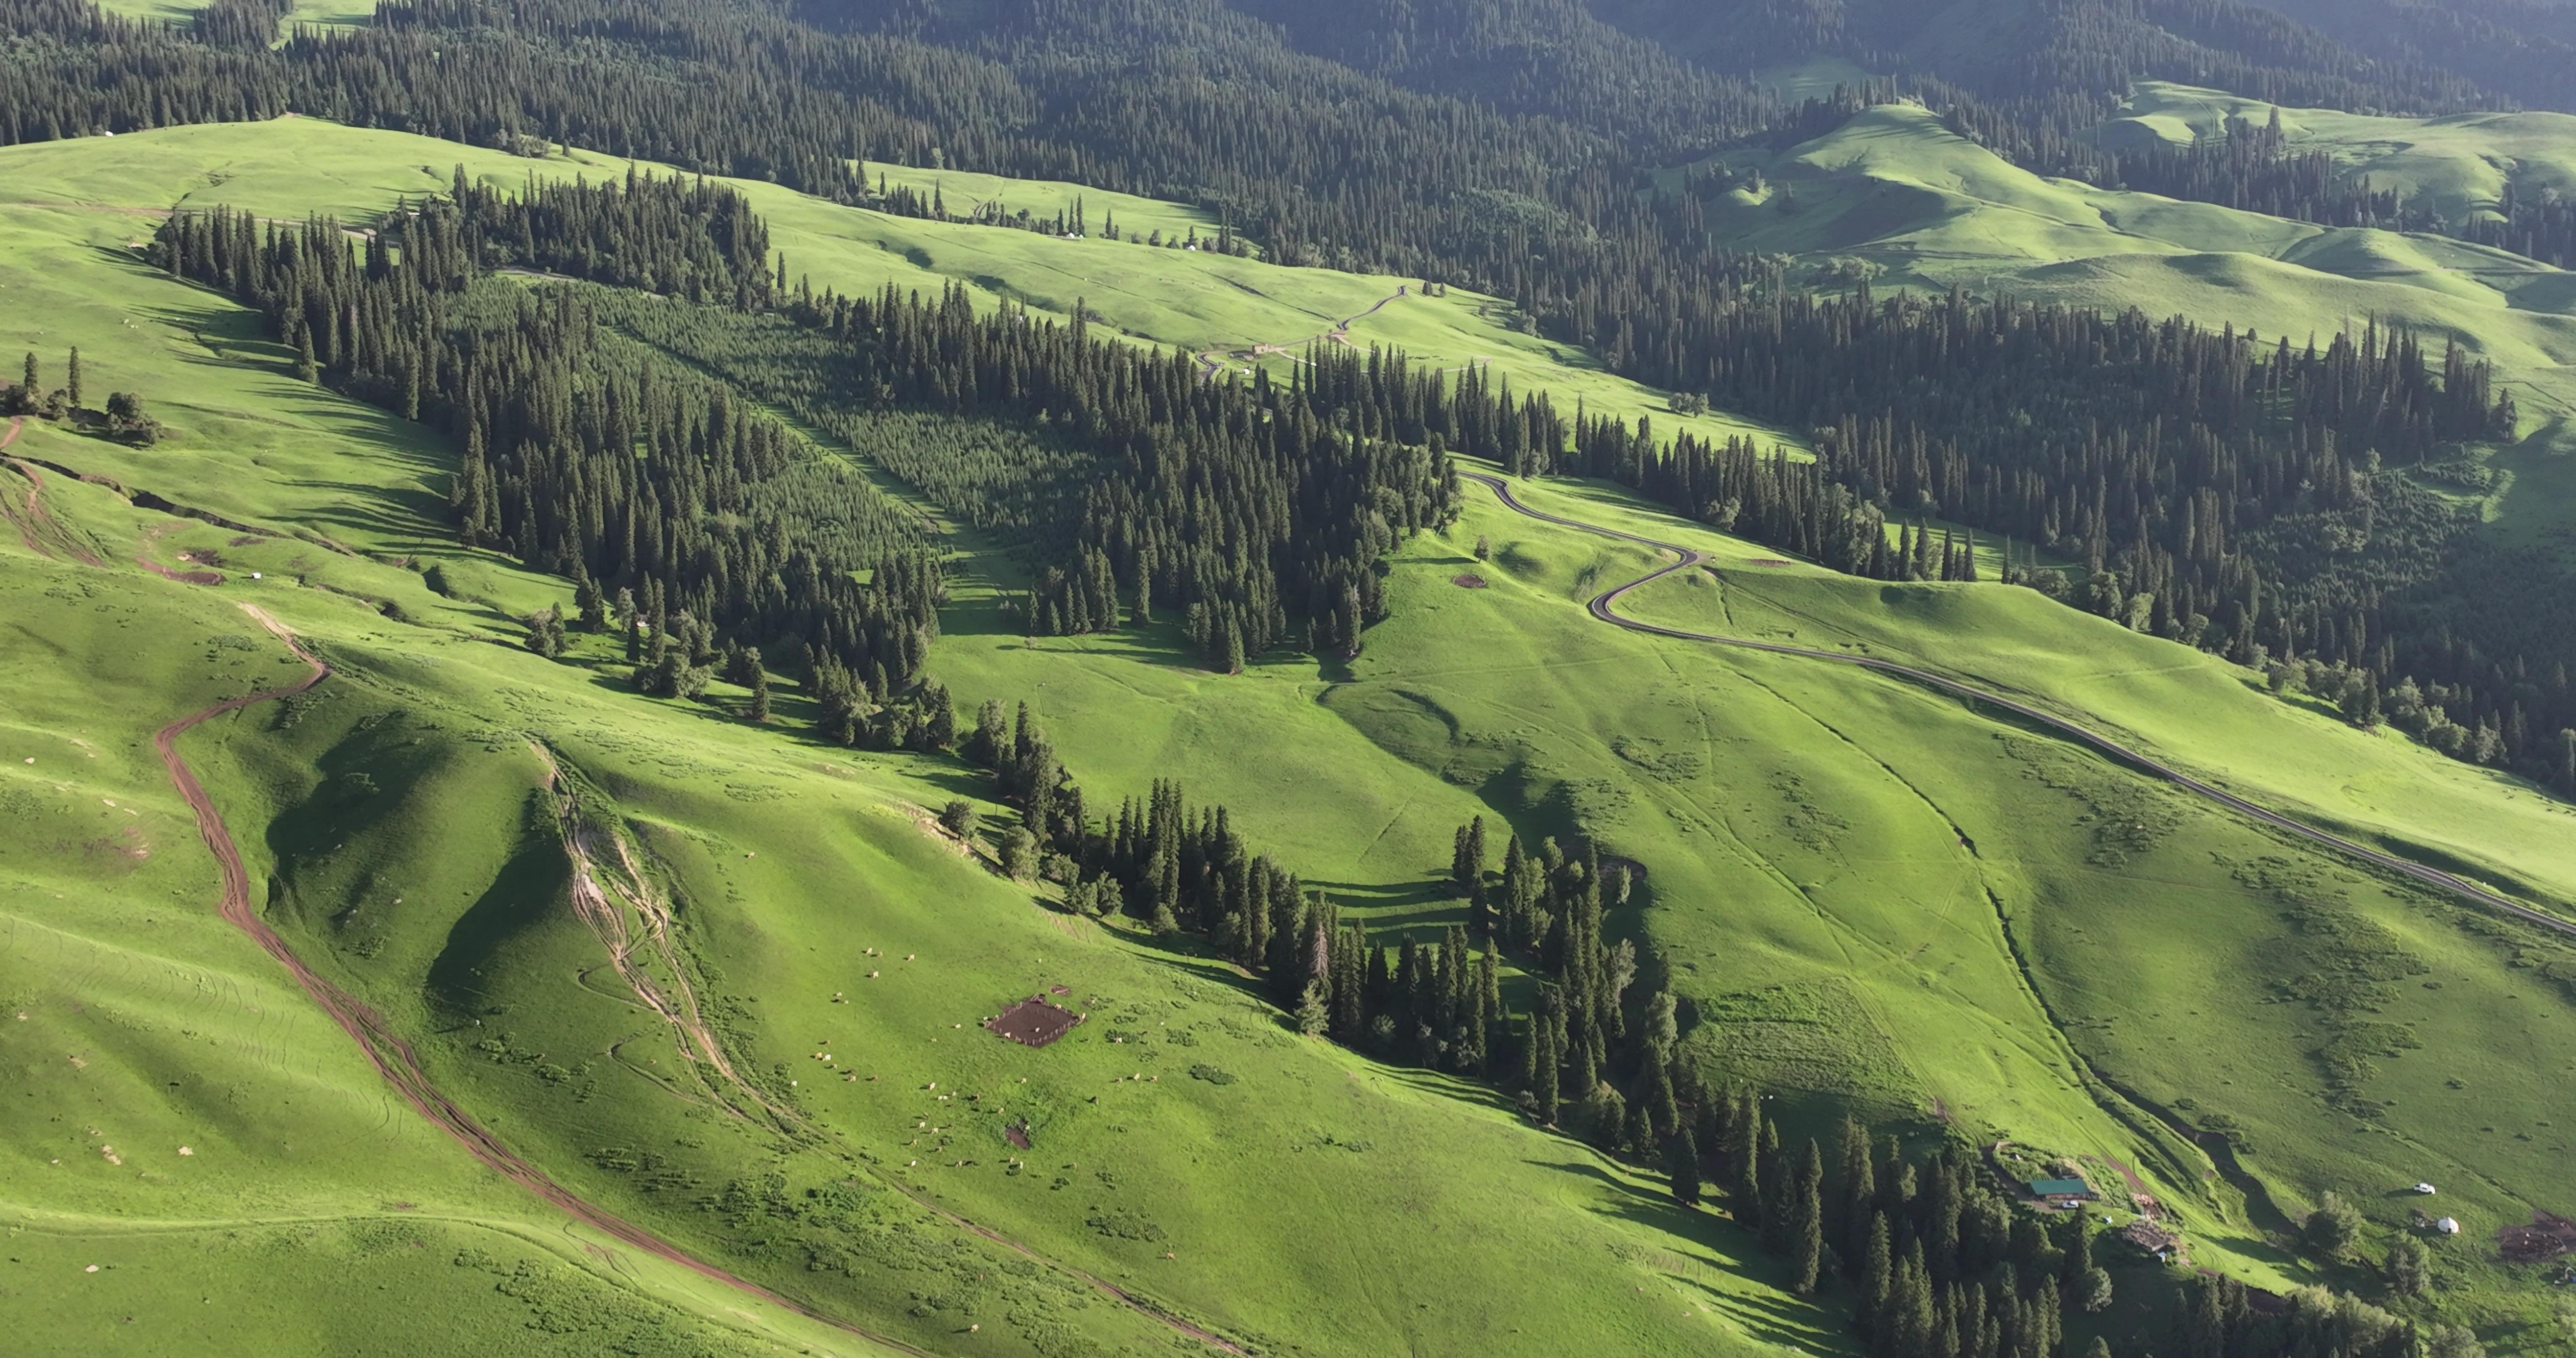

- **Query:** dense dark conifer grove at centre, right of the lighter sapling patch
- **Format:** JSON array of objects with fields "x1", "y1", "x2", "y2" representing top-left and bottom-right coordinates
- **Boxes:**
[{"x1": 762, "y1": 286, "x2": 1456, "y2": 672}]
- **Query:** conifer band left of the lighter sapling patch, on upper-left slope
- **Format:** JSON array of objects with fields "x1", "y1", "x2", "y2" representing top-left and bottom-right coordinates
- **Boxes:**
[{"x1": 152, "y1": 193, "x2": 943, "y2": 696}]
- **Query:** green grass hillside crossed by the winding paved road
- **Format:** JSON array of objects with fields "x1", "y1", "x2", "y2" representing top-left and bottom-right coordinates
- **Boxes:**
[{"x1": 1324, "y1": 487, "x2": 2576, "y2": 1314}]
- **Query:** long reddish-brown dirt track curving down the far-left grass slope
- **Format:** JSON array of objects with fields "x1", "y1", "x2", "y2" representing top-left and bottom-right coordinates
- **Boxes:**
[{"x1": 152, "y1": 603, "x2": 930, "y2": 1358}]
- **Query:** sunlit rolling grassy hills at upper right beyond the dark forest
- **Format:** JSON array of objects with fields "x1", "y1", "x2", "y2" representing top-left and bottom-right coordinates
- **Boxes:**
[{"x1": 1713, "y1": 97, "x2": 2576, "y2": 621}]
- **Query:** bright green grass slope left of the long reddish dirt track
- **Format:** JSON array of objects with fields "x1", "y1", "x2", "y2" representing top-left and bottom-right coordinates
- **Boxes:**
[{"x1": 0, "y1": 484, "x2": 907, "y2": 1355}]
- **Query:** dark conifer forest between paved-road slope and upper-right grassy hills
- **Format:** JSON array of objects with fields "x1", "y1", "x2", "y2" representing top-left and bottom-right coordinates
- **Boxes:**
[{"x1": 1517, "y1": 284, "x2": 2576, "y2": 791}]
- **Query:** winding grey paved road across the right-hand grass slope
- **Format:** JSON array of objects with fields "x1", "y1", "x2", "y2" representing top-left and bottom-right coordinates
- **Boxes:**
[{"x1": 1458, "y1": 469, "x2": 2576, "y2": 938}]
